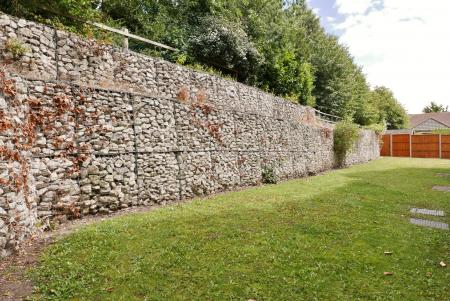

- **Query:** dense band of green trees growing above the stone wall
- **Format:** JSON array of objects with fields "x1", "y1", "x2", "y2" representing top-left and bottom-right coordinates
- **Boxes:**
[{"x1": 0, "y1": 0, "x2": 406, "y2": 124}]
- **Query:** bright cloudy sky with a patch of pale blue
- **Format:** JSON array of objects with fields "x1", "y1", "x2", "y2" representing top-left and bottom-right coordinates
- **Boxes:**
[{"x1": 307, "y1": 0, "x2": 450, "y2": 114}]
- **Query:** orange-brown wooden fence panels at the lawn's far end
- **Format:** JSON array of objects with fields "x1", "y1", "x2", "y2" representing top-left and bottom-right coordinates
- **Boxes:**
[{"x1": 381, "y1": 134, "x2": 450, "y2": 159}]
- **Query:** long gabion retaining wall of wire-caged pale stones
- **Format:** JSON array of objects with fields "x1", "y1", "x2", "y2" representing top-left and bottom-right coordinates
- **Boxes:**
[{"x1": 0, "y1": 14, "x2": 379, "y2": 254}]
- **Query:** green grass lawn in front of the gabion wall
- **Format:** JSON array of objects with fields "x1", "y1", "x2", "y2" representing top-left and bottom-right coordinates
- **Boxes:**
[{"x1": 31, "y1": 158, "x2": 450, "y2": 301}]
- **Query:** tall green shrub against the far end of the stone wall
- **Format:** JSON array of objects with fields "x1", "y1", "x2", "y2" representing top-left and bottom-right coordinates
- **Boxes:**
[{"x1": 333, "y1": 120, "x2": 359, "y2": 166}]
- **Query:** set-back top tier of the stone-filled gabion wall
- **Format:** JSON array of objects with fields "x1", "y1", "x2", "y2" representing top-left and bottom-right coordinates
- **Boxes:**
[{"x1": 0, "y1": 12, "x2": 314, "y2": 119}]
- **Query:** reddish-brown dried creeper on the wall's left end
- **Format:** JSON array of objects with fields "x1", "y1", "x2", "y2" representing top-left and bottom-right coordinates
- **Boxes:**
[{"x1": 0, "y1": 69, "x2": 103, "y2": 209}]
